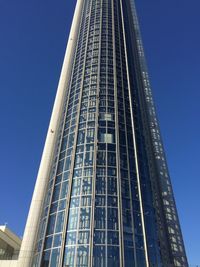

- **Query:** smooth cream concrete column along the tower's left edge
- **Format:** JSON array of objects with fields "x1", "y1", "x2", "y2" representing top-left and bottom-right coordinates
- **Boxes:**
[{"x1": 18, "y1": 0, "x2": 84, "y2": 267}]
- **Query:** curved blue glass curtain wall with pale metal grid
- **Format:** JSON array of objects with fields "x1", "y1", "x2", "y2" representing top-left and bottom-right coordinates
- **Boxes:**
[{"x1": 32, "y1": 0, "x2": 188, "y2": 267}]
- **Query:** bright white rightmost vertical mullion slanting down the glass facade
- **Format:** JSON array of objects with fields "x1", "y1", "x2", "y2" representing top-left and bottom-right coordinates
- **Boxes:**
[{"x1": 120, "y1": 0, "x2": 149, "y2": 267}]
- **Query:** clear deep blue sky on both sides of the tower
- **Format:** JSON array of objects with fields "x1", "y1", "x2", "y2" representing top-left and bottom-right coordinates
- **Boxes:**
[{"x1": 0, "y1": 0, "x2": 200, "y2": 264}]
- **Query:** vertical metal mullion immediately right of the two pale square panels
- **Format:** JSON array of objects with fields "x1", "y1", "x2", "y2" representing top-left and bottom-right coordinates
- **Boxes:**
[{"x1": 112, "y1": 0, "x2": 124, "y2": 267}]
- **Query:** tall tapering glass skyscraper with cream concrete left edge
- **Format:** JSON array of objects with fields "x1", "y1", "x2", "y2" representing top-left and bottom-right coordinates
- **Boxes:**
[{"x1": 19, "y1": 0, "x2": 188, "y2": 267}]
